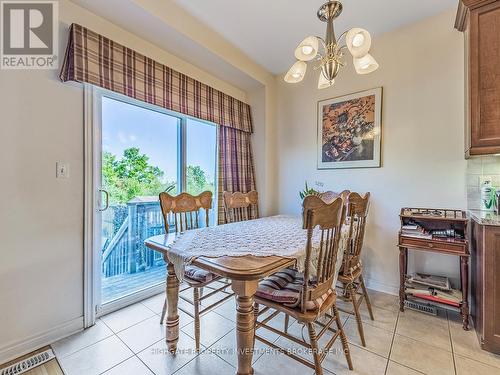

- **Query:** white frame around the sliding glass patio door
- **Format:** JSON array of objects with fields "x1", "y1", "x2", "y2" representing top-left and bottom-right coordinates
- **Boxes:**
[{"x1": 83, "y1": 84, "x2": 219, "y2": 328}]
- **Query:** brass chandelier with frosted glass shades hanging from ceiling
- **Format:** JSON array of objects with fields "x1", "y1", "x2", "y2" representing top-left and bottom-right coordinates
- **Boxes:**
[{"x1": 285, "y1": 1, "x2": 379, "y2": 89}]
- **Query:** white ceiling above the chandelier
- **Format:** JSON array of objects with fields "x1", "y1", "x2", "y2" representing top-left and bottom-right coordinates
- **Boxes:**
[{"x1": 175, "y1": 0, "x2": 458, "y2": 74}]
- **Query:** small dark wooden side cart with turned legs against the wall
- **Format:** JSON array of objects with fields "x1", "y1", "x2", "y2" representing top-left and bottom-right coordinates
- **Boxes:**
[{"x1": 398, "y1": 208, "x2": 470, "y2": 330}]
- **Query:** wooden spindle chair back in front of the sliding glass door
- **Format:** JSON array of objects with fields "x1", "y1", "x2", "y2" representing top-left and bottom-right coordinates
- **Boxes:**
[{"x1": 160, "y1": 191, "x2": 212, "y2": 233}]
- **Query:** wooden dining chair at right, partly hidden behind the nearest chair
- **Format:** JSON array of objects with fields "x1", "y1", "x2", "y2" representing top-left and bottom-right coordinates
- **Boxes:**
[{"x1": 338, "y1": 193, "x2": 374, "y2": 346}]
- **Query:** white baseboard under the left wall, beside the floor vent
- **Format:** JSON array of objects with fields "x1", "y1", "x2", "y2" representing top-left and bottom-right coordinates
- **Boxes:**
[{"x1": 0, "y1": 317, "x2": 83, "y2": 364}]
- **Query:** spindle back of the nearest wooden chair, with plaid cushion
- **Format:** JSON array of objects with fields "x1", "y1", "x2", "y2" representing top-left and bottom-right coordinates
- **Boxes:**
[{"x1": 302, "y1": 195, "x2": 345, "y2": 311}]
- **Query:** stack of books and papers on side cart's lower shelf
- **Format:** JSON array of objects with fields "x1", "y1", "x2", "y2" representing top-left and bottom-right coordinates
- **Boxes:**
[{"x1": 405, "y1": 273, "x2": 462, "y2": 307}]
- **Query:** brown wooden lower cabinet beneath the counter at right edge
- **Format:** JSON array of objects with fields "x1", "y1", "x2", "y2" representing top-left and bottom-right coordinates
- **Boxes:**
[{"x1": 471, "y1": 217, "x2": 500, "y2": 354}]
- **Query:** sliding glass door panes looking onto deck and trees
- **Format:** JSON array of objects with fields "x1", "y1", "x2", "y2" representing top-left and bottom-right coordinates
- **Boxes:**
[{"x1": 94, "y1": 90, "x2": 217, "y2": 315}]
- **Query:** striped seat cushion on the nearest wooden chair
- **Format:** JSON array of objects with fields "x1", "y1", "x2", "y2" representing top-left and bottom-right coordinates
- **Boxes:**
[{"x1": 255, "y1": 268, "x2": 333, "y2": 310}]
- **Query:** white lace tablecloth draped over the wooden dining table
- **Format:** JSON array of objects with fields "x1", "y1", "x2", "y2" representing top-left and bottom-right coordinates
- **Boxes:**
[{"x1": 168, "y1": 215, "x2": 348, "y2": 281}]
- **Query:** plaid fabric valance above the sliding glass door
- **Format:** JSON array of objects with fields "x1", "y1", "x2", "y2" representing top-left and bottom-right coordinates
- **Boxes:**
[{"x1": 60, "y1": 24, "x2": 252, "y2": 133}]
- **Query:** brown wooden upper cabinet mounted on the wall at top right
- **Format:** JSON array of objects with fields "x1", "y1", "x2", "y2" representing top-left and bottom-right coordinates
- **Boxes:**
[{"x1": 455, "y1": 0, "x2": 500, "y2": 157}]
